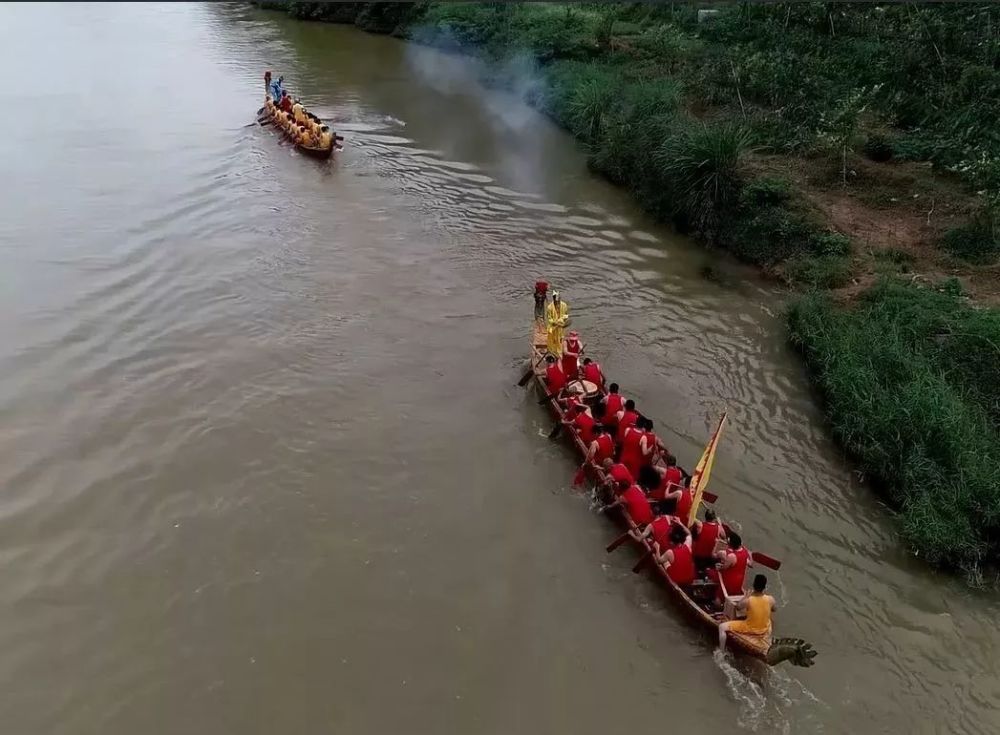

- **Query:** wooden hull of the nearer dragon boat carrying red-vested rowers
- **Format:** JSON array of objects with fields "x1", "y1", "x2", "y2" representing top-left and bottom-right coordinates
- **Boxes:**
[{"x1": 531, "y1": 318, "x2": 771, "y2": 661}]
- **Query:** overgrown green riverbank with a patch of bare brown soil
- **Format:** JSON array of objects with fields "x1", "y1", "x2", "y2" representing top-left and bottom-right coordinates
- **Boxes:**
[{"x1": 256, "y1": 3, "x2": 1000, "y2": 577}]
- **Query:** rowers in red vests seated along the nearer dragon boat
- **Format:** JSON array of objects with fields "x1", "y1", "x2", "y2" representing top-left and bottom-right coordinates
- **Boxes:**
[{"x1": 545, "y1": 350, "x2": 753, "y2": 601}]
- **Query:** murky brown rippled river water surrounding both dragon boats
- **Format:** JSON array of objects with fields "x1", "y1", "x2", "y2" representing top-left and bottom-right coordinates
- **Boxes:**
[{"x1": 0, "y1": 4, "x2": 1000, "y2": 735}]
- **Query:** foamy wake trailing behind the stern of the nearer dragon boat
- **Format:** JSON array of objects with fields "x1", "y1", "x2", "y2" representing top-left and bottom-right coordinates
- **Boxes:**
[{"x1": 712, "y1": 649, "x2": 826, "y2": 733}]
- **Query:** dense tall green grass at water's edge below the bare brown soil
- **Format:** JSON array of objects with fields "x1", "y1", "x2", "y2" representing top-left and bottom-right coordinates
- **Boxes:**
[{"x1": 789, "y1": 281, "x2": 1000, "y2": 570}]
